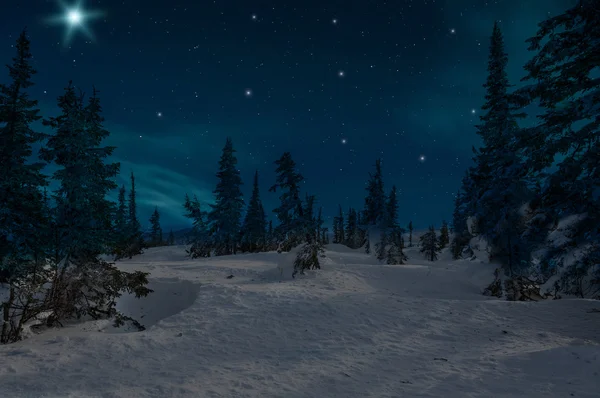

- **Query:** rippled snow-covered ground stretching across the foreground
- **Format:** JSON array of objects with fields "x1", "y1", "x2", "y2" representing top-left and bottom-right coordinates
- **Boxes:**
[{"x1": 0, "y1": 245, "x2": 600, "y2": 398}]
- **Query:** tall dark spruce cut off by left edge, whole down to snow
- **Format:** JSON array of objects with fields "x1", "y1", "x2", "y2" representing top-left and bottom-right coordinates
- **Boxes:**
[{"x1": 0, "y1": 31, "x2": 50, "y2": 343}]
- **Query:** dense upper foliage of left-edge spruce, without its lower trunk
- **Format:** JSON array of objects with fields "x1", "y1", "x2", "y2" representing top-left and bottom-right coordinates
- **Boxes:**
[{"x1": 0, "y1": 31, "x2": 47, "y2": 281}]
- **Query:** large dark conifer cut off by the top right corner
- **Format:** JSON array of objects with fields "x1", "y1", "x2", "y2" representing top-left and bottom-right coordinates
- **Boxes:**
[{"x1": 518, "y1": 0, "x2": 600, "y2": 291}]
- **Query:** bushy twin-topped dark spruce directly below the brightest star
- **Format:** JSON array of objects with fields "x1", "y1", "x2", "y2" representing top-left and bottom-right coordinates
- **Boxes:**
[{"x1": 40, "y1": 83, "x2": 119, "y2": 264}]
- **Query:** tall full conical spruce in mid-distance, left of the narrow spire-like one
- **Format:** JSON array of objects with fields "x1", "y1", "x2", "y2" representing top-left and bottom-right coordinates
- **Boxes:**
[{"x1": 208, "y1": 138, "x2": 244, "y2": 255}]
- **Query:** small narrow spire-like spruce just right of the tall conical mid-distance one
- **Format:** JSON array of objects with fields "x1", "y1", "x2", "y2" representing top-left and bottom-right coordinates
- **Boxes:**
[{"x1": 241, "y1": 170, "x2": 267, "y2": 252}]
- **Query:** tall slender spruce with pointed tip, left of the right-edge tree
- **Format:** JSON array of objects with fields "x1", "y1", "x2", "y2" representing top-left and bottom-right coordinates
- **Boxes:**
[{"x1": 470, "y1": 22, "x2": 529, "y2": 268}]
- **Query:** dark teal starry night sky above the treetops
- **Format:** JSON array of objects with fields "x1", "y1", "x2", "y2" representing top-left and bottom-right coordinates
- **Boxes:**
[{"x1": 0, "y1": 0, "x2": 572, "y2": 230}]
